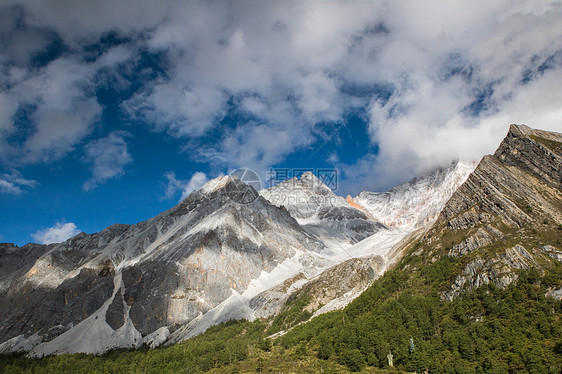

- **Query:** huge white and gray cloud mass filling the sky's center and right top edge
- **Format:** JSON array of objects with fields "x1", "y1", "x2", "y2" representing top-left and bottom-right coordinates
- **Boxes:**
[{"x1": 123, "y1": 1, "x2": 562, "y2": 188}]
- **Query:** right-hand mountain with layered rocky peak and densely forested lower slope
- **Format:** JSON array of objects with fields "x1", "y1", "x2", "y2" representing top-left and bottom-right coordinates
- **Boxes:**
[{"x1": 260, "y1": 125, "x2": 562, "y2": 373}]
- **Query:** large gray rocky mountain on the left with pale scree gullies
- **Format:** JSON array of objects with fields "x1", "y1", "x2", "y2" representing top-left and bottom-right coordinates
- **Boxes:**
[{"x1": 0, "y1": 177, "x2": 326, "y2": 356}]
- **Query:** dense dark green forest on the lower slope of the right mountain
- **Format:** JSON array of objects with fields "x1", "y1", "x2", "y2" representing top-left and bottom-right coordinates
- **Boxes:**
[{"x1": 279, "y1": 260, "x2": 562, "y2": 373}]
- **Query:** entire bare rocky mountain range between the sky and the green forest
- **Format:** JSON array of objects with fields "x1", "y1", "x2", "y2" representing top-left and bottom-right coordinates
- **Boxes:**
[{"x1": 0, "y1": 126, "x2": 562, "y2": 356}]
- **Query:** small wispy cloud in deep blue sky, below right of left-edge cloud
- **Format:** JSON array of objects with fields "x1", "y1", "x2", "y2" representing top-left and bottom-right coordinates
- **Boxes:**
[{"x1": 83, "y1": 131, "x2": 133, "y2": 191}]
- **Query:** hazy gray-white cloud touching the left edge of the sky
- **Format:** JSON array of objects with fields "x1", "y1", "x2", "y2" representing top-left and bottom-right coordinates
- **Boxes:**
[{"x1": 0, "y1": 47, "x2": 127, "y2": 166}]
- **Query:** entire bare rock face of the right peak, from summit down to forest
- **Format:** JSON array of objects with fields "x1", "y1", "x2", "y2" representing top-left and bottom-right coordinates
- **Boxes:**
[{"x1": 426, "y1": 125, "x2": 562, "y2": 300}]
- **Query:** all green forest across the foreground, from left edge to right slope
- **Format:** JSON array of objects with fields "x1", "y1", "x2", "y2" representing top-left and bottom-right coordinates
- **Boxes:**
[{"x1": 0, "y1": 221, "x2": 562, "y2": 373}]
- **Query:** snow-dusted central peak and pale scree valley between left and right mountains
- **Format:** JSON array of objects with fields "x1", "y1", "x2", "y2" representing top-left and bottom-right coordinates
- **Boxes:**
[{"x1": 252, "y1": 168, "x2": 475, "y2": 320}]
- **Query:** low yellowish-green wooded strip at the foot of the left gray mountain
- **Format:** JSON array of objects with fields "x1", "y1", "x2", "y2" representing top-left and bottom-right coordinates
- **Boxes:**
[{"x1": 0, "y1": 321, "x2": 260, "y2": 374}]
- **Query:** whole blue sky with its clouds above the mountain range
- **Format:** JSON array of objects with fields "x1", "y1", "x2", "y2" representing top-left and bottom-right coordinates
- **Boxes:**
[{"x1": 0, "y1": 0, "x2": 562, "y2": 245}]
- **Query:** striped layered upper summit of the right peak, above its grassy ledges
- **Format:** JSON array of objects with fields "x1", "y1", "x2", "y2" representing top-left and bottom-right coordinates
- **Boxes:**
[{"x1": 440, "y1": 125, "x2": 562, "y2": 230}]
